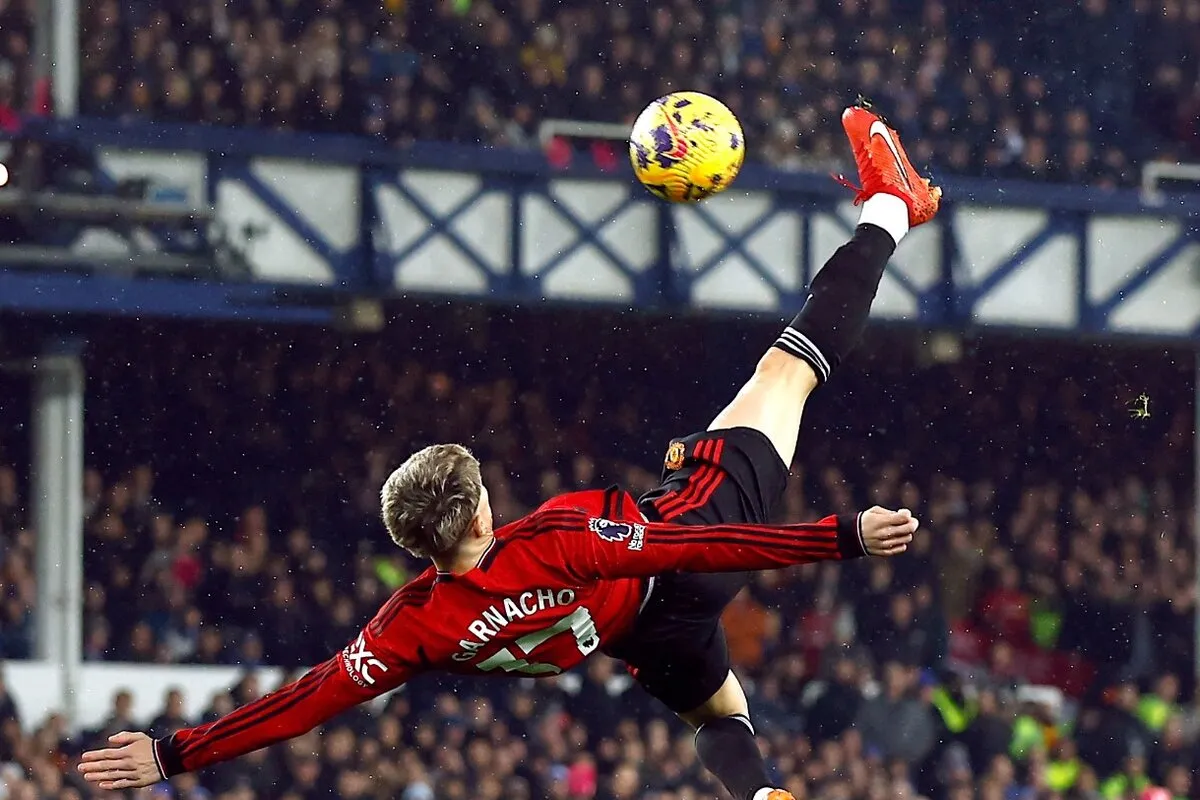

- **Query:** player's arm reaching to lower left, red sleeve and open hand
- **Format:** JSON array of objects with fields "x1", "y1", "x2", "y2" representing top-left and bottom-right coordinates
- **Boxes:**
[{"x1": 79, "y1": 638, "x2": 408, "y2": 789}]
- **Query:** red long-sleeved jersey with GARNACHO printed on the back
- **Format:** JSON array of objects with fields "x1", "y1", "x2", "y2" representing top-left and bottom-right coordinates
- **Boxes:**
[{"x1": 155, "y1": 489, "x2": 864, "y2": 776}]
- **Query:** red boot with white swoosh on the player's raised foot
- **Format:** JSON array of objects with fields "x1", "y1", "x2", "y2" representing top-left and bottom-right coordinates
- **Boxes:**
[{"x1": 834, "y1": 100, "x2": 942, "y2": 228}]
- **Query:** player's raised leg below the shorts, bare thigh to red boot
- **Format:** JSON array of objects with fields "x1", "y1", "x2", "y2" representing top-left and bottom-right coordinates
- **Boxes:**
[{"x1": 709, "y1": 98, "x2": 941, "y2": 465}]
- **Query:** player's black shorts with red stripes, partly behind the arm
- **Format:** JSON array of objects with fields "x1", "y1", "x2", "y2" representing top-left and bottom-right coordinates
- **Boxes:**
[{"x1": 607, "y1": 428, "x2": 787, "y2": 714}]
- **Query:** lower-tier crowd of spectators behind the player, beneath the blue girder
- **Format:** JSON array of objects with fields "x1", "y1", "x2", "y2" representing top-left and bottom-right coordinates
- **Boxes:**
[{"x1": 0, "y1": 306, "x2": 1200, "y2": 800}]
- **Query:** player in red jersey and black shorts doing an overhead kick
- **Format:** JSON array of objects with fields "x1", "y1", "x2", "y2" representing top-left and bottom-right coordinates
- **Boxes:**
[{"x1": 79, "y1": 103, "x2": 941, "y2": 800}]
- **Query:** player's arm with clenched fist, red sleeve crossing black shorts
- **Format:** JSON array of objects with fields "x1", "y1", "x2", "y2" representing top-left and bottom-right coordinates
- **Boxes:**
[{"x1": 539, "y1": 506, "x2": 918, "y2": 581}]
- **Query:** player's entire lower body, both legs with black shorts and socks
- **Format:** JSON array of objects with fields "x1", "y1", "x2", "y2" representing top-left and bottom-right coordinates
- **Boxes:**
[{"x1": 611, "y1": 100, "x2": 938, "y2": 800}]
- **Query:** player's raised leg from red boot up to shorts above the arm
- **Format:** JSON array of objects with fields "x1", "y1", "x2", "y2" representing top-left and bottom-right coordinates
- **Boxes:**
[{"x1": 643, "y1": 106, "x2": 941, "y2": 524}]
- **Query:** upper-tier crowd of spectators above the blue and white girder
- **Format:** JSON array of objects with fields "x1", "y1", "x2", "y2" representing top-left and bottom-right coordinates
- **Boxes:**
[{"x1": 58, "y1": 0, "x2": 1200, "y2": 186}]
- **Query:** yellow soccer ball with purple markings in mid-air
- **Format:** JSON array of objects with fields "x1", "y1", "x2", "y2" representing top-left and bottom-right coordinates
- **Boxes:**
[{"x1": 629, "y1": 91, "x2": 746, "y2": 203}]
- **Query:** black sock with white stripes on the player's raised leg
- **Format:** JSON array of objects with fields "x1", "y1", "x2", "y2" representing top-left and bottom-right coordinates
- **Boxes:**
[{"x1": 775, "y1": 224, "x2": 896, "y2": 383}]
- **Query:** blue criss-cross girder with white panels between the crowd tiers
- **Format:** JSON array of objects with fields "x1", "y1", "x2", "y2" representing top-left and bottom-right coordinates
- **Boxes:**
[{"x1": 0, "y1": 120, "x2": 1200, "y2": 338}]
